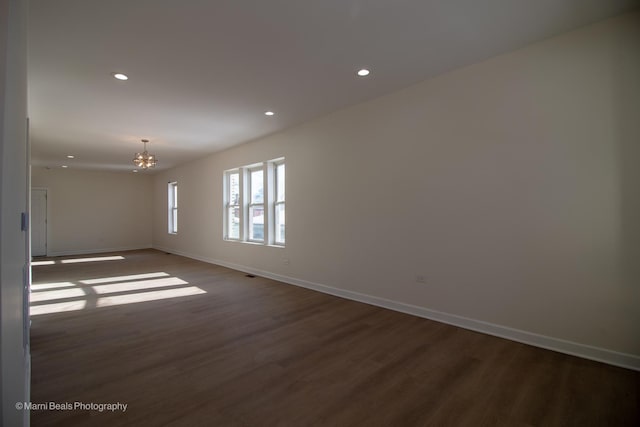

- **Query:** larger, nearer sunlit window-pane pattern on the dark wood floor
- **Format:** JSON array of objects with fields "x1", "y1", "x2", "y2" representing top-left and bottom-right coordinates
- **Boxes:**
[{"x1": 30, "y1": 272, "x2": 207, "y2": 316}]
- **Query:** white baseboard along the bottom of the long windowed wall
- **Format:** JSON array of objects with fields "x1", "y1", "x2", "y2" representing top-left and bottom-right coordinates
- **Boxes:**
[{"x1": 154, "y1": 246, "x2": 640, "y2": 371}]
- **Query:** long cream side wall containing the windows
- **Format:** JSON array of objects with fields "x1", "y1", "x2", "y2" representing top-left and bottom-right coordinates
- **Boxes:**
[{"x1": 153, "y1": 13, "x2": 640, "y2": 369}]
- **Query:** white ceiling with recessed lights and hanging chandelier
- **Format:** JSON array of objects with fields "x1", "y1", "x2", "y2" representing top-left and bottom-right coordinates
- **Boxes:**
[{"x1": 28, "y1": 0, "x2": 638, "y2": 171}]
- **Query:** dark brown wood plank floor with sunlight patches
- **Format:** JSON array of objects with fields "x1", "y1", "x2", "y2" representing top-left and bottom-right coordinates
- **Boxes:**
[{"x1": 31, "y1": 250, "x2": 640, "y2": 427}]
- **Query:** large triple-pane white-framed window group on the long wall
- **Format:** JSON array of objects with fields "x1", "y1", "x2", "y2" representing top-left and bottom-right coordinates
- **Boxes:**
[{"x1": 224, "y1": 159, "x2": 285, "y2": 246}]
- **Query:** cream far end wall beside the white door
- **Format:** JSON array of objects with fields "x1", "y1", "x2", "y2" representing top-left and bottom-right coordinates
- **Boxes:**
[{"x1": 31, "y1": 167, "x2": 153, "y2": 256}]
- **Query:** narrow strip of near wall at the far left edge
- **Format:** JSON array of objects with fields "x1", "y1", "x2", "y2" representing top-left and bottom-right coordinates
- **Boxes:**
[{"x1": 0, "y1": 0, "x2": 30, "y2": 426}]
